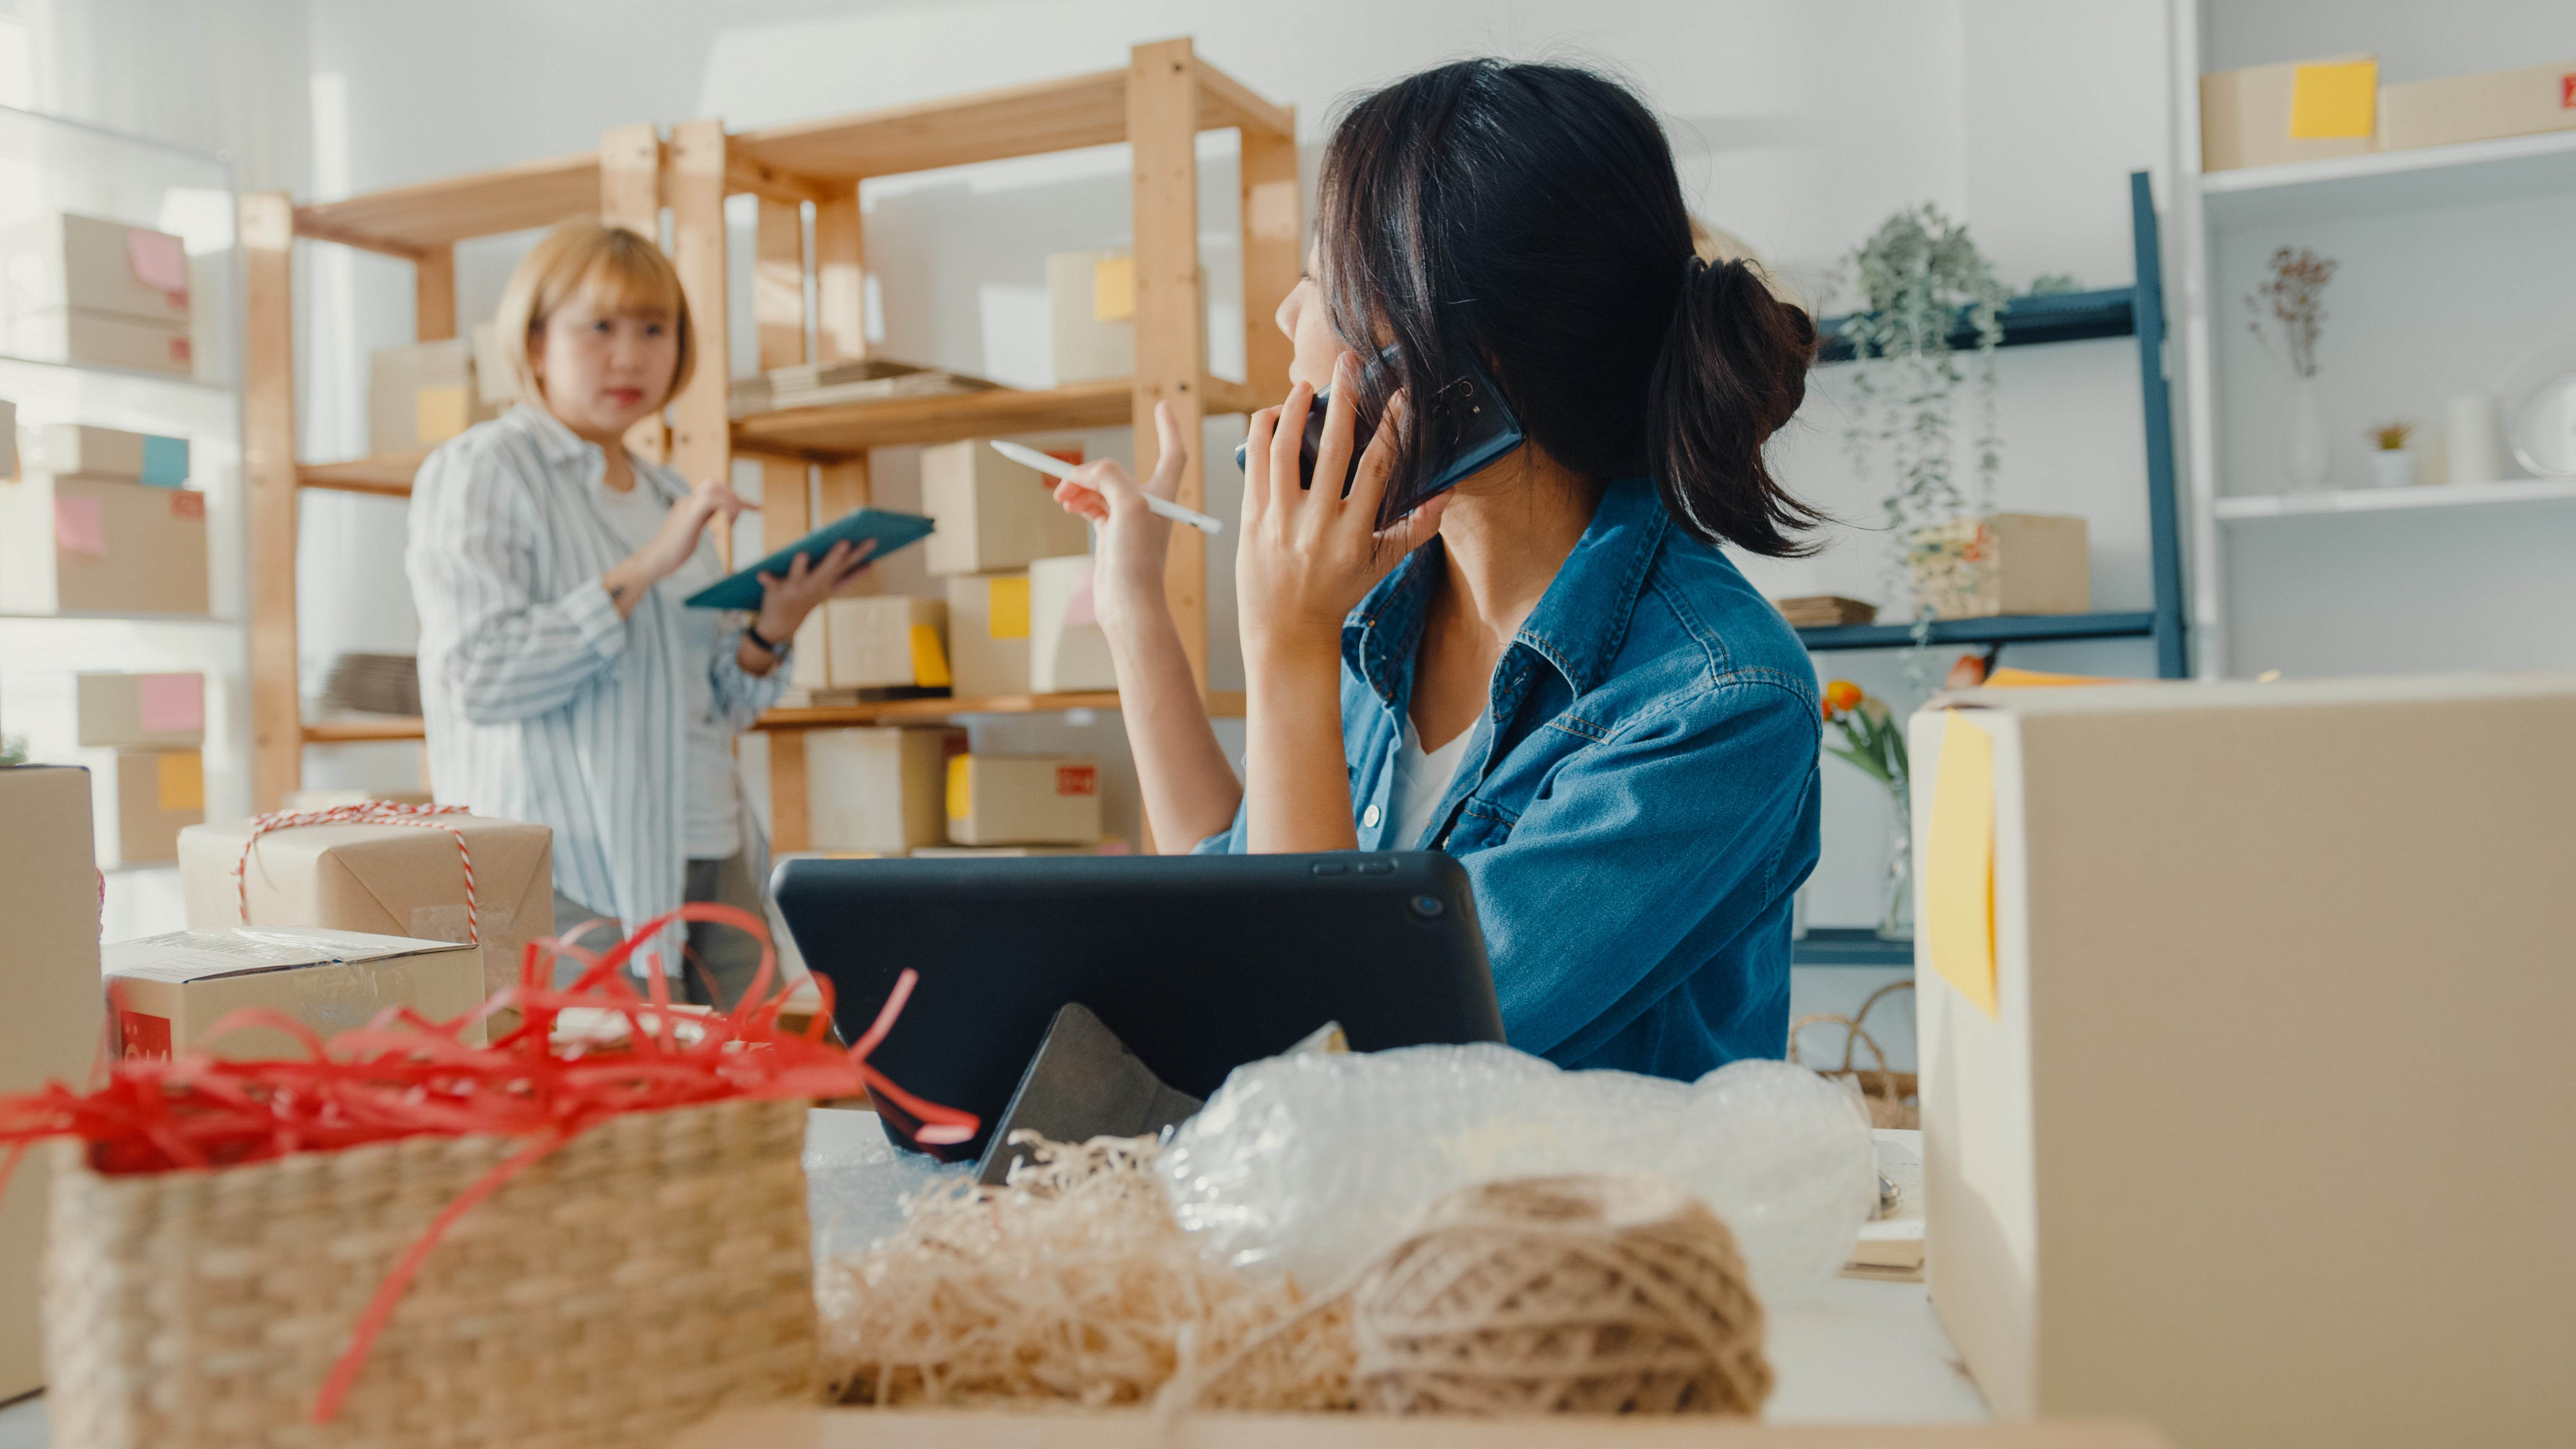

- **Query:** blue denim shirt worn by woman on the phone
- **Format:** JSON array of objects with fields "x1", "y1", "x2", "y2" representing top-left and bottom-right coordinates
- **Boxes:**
[{"x1": 1198, "y1": 477, "x2": 1824, "y2": 1078}]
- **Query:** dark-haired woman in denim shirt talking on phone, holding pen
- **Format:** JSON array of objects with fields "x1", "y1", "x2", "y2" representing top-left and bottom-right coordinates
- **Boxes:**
[{"x1": 1056, "y1": 59, "x2": 1821, "y2": 1078}]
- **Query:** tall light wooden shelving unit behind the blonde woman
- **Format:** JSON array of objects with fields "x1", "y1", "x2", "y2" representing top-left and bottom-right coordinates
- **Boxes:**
[{"x1": 242, "y1": 39, "x2": 1301, "y2": 848}]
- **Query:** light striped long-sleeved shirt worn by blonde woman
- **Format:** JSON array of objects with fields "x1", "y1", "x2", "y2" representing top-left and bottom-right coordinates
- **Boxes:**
[{"x1": 405, "y1": 408, "x2": 786, "y2": 949}]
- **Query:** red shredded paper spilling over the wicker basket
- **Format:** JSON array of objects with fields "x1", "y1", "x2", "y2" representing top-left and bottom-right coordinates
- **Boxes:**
[{"x1": 0, "y1": 902, "x2": 979, "y2": 1423}]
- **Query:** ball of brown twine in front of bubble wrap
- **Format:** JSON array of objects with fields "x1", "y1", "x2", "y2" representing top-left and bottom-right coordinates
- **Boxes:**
[{"x1": 1353, "y1": 1176, "x2": 1772, "y2": 1415}]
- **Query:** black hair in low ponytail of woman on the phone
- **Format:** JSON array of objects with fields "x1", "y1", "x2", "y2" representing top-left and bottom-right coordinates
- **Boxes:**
[{"x1": 1317, "y1": 59, "x2": 1821, "y2": 557}]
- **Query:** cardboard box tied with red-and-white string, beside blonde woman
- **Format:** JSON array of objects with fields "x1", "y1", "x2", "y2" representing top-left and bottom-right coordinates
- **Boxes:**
[{"x1": 178, "y1": 815, "x2": 554, "y2": 1000}]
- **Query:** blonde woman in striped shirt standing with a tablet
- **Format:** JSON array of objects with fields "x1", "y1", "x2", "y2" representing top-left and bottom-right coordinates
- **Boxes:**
[{"x1": 405, "y1": 222, "x2": 865, "y2": 1005}]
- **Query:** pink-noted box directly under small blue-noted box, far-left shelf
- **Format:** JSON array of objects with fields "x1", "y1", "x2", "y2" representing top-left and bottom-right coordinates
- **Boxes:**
[{"x1": 0, "y1": 472, "x2": 206, "y2": 614}]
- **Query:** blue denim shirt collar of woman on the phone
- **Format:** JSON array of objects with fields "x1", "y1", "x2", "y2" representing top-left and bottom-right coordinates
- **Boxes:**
[{"x1": 1342, "y1": 477, "x2": 1672, "y2": 724}]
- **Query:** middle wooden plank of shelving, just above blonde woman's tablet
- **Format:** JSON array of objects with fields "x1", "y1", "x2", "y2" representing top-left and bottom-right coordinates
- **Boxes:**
[{"x1": 734, "y1": 377, "x2": 1265, "y2": 459}]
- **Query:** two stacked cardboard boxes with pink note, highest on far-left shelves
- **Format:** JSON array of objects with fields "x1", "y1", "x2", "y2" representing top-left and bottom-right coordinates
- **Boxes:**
[{"x1": 0, "y1": 211, "x2": 196, "y2": 377}]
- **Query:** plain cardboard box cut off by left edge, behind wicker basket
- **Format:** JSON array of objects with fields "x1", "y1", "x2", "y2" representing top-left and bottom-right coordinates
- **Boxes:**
[{"x1": 0, "y1": 766, "x2": 103, "y2": 1402}]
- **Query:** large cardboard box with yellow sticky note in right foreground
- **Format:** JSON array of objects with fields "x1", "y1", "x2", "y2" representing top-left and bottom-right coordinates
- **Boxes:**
[{"x1": 1909, "y1": 673, "x2": 2576, "y2": 1446}]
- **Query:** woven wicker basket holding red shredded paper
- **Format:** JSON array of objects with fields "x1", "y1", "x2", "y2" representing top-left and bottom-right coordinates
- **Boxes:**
[{"x1": 44, "y1": 1101, "x2": 814, "y2": 1449}]
